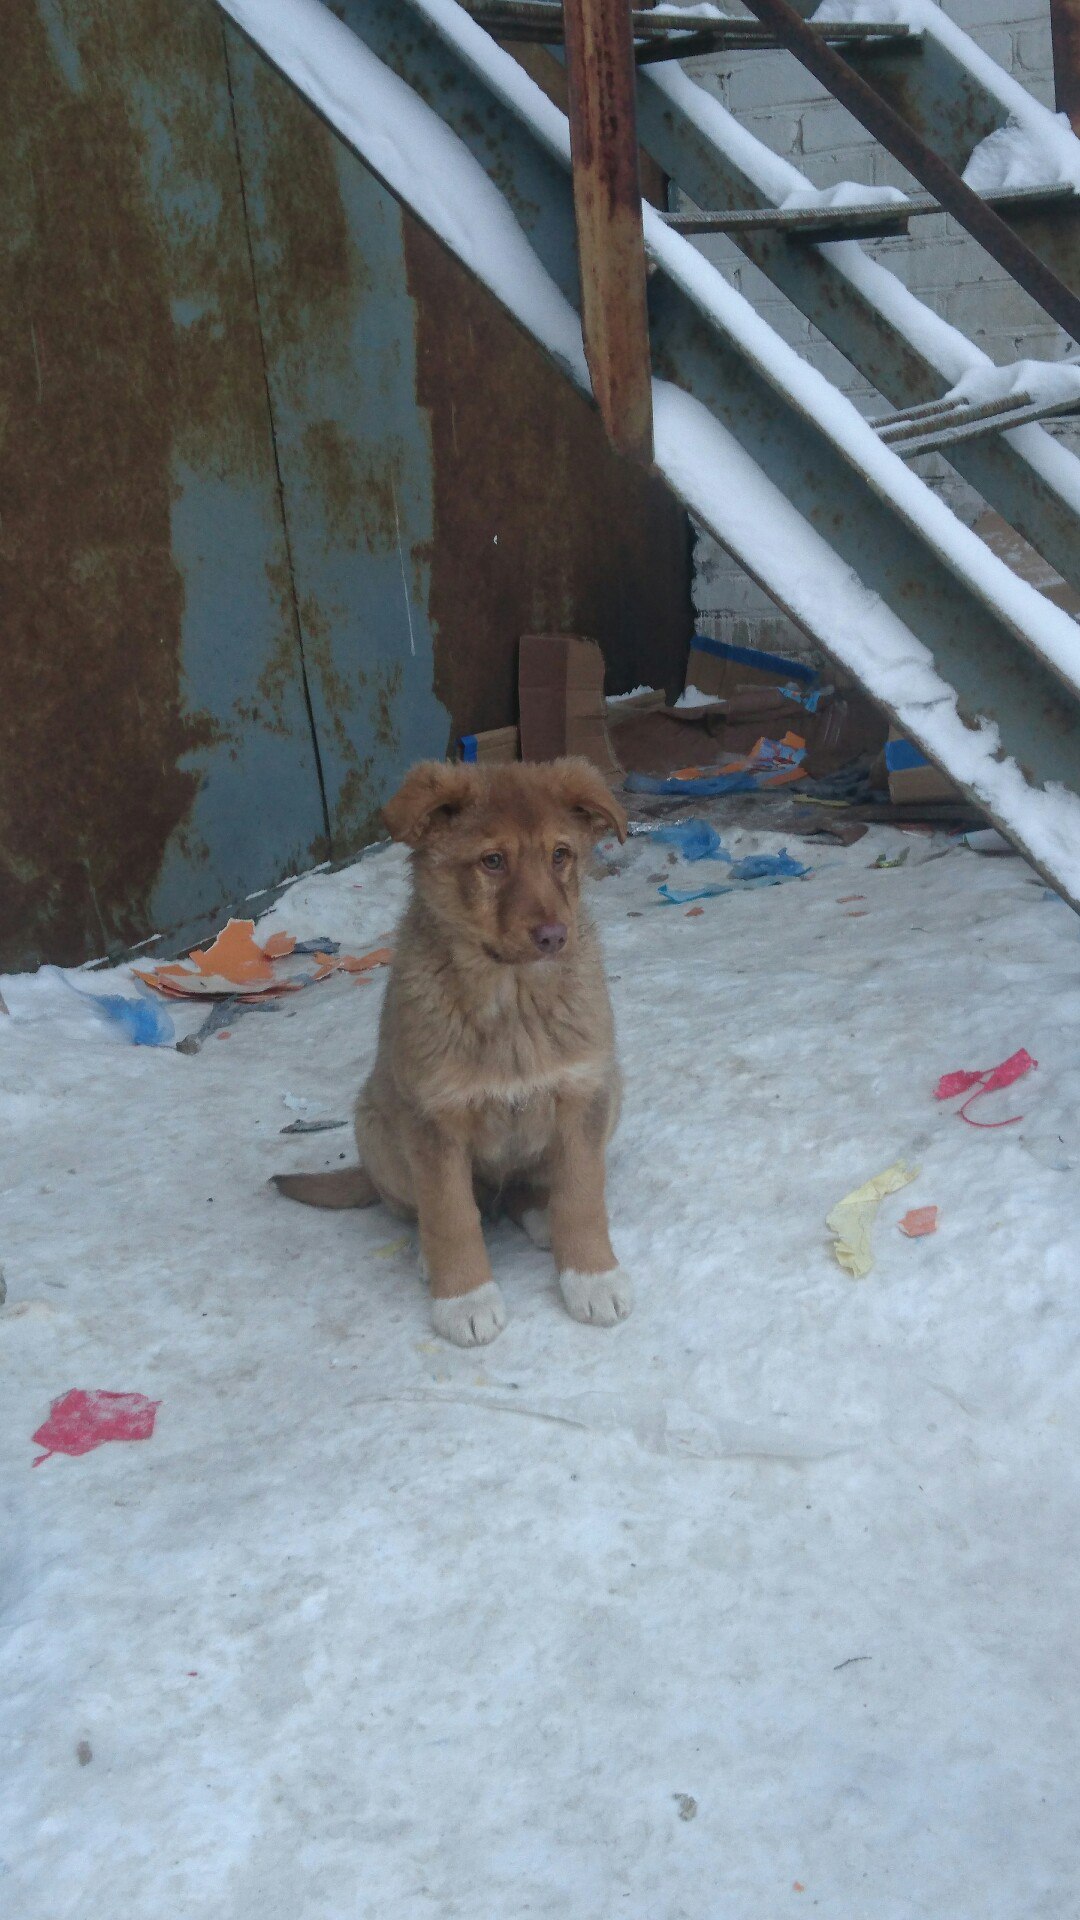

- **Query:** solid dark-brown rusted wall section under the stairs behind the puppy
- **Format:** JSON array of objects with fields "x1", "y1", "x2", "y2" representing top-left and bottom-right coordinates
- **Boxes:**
[{"x1": 404, "y1": 217, "x2": 692, "y2": 733}]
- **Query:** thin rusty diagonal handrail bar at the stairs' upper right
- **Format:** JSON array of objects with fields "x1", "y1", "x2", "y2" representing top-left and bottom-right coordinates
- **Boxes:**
[{"x1": 734, "y1": 0, "x2": 1080, "y2": 342}]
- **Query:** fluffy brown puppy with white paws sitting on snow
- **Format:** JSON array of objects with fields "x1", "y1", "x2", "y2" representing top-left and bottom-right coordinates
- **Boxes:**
[{"x1": 277, "y1": 760, "x2": 632, "y2": 1346}]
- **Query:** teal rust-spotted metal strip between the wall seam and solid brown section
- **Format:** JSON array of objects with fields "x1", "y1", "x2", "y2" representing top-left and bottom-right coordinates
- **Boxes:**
[{"x1": 225, "y1": 25, "x2": 450, "y2": 856}]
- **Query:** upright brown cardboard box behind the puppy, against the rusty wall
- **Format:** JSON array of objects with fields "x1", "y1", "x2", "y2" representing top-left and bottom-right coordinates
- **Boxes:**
[{"x1": 517, "y1": 634, "x2": 623, "y2": 781}]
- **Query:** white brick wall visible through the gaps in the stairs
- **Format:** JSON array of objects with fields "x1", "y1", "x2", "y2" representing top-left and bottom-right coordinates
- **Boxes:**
[{"x1": 686, "y1": 0, "x2": 1080, "y2": 653}]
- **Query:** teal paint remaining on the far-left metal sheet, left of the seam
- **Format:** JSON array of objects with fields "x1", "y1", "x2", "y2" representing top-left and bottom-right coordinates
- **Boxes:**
[{"x1": 95, "y1": 0, "x2": 329, "y2": 927}]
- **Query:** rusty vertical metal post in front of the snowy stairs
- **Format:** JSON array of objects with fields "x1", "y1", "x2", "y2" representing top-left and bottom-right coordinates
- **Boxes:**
[{"x1": 563, "y1": 0, "x2": 653, "y2": 465}]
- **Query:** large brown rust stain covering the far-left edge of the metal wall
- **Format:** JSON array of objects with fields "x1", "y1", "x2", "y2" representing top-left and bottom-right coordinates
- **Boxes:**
[{"x1": 0, "y1": 6, "x2": 242, "y2": 966}]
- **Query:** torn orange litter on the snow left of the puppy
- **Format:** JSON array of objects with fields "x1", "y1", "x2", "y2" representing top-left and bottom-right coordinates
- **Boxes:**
[{"x1": 133, "y1": 920, "x2": 392, "y2": 1006}]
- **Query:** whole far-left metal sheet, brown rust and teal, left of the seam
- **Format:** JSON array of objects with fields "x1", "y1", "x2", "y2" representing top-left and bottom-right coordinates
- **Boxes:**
[{"x1": 0, "y1": 0, "x2": 325, "y2": 966}]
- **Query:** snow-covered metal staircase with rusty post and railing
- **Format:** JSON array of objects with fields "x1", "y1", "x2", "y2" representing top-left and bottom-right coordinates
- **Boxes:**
[{"x1": 217, "y1": 0, "x2": 1080, "y2": 906}]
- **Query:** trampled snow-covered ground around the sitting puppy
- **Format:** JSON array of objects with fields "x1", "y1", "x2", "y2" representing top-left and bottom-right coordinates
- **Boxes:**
[{"x1": 0, "y1": 829, "x2": 1080, "y2": 1920}]
